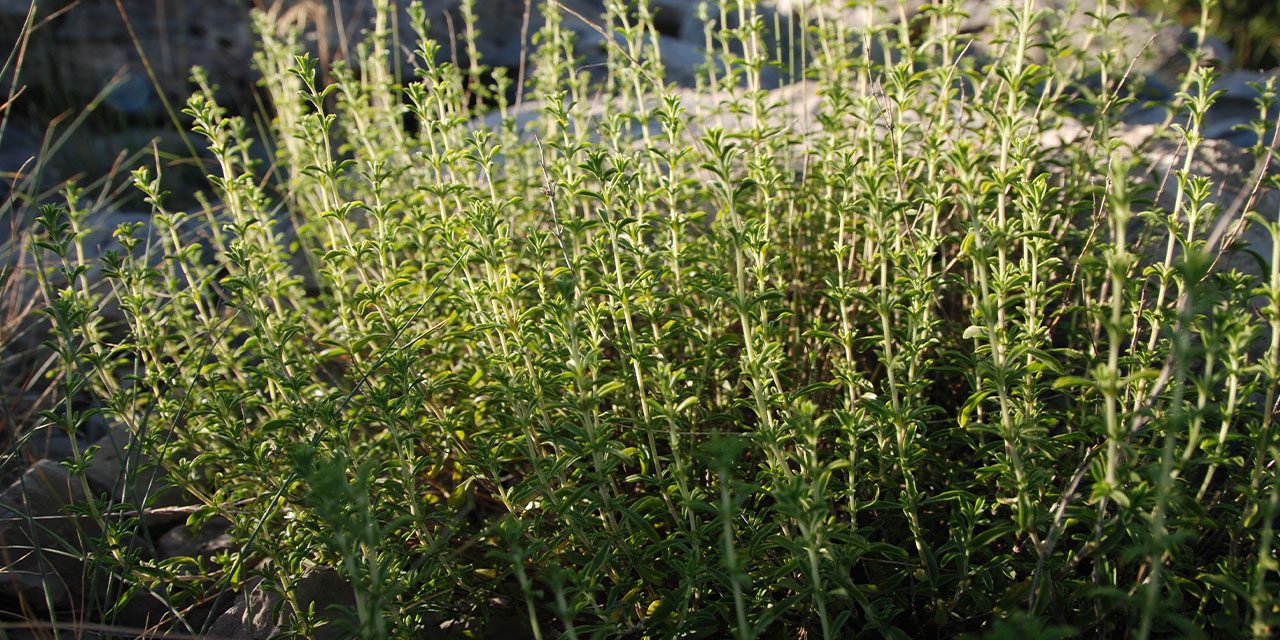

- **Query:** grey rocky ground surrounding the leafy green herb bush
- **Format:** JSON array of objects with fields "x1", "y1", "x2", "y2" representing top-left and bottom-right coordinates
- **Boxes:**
[{"x1": 0, "y1": 0, "x2": 1276, "y2": 639}]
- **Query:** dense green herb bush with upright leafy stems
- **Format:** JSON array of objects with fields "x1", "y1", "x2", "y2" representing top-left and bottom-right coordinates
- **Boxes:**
[{"x1": 17, "y1": 0, "x2": 1280, "y2": 639}]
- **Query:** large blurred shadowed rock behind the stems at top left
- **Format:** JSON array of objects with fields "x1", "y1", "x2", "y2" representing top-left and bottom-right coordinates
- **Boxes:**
[{"x1": 0, "y1": 0, "x2": 603, "y2": 122}]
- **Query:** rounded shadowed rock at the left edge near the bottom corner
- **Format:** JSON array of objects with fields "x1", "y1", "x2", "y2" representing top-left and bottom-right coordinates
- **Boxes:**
[{"x1": 0, "y1": 458, "x2": 96, "y2": 611}]
